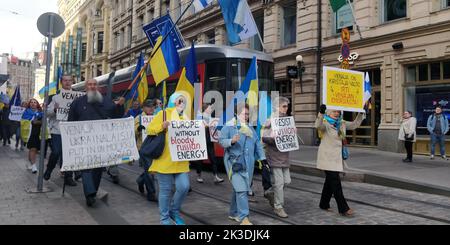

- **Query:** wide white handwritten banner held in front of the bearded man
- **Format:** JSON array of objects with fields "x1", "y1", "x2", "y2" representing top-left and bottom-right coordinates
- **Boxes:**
[{"x1": 60, "y1": 118, "x2": 139, "y2": 172}]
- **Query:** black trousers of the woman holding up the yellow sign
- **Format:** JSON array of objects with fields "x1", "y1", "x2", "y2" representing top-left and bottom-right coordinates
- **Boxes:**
[{"x1": 320, "y1": 171, "x2": 350, "y2": 214}]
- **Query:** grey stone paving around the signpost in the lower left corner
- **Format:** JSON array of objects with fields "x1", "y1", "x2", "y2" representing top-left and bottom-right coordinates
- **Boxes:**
[{"x1": 0, "y1": 146, "x2": 97, "y2": 225}]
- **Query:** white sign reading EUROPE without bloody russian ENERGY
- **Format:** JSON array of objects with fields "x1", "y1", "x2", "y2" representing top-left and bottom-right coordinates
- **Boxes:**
[{"x1": 169, "y1": 120, "x2": 208, "y2": 162}]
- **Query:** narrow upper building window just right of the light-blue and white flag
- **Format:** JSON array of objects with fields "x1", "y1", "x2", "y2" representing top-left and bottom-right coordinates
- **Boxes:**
[{"x1": 283, "y1": 2, "x2": 297, "y2": 47}]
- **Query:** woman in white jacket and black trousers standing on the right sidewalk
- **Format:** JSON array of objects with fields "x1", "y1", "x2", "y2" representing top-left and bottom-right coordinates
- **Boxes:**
[{"x1": 398, "y1": 111, "x2": 417, "y2": 162}]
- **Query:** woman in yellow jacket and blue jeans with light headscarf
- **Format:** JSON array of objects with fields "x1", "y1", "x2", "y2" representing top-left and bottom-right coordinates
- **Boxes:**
[{"x1": 147, "y1": 93, "x2": 190, "y2": 225}]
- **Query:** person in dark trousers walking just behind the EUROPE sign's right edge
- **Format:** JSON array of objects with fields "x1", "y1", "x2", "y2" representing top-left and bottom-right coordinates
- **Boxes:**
[{"x1": 193, "y1": 103, "x2": 224, "y2": 184}]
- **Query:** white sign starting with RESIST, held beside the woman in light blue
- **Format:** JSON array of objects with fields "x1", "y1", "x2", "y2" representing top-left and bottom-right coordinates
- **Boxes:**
[{"x1": 271, "y1": 117, "x2": 300, "y2": 152}]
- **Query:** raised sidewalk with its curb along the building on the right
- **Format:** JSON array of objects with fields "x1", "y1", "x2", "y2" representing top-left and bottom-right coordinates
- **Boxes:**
[{"x1": 291, "y1": 146, "x2": 450, "y2": 196}]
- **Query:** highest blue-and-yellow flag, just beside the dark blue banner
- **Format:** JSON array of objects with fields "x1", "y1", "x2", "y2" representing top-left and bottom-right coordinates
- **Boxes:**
[{"x1": 150, "y1": 22, "x2": 180, "y2": 86}]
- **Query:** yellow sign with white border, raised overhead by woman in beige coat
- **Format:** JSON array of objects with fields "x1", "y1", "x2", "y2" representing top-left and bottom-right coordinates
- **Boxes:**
[{"x1": 322, "y1": 66, "x2": 364, "y2": 112}]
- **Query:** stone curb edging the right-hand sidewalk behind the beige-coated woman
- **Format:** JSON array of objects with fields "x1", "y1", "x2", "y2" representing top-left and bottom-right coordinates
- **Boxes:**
[{"x1": 291, "y1": 160, "x2": 450, "y2": 197}]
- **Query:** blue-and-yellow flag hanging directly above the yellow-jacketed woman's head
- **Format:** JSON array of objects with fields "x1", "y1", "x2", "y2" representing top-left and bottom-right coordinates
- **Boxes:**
[{"x1": 175, "y1": 44, "x2": 198, "y2": 119}]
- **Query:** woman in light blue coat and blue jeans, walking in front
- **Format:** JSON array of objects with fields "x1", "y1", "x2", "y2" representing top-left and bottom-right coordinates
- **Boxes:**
[{"x1": 219, "y1": 104, "x2": 266, "y2": 225}]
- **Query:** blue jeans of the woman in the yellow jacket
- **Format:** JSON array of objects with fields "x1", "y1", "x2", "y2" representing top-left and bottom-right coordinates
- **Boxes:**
[{"x1": 157, "y1": 173, "x2": 189, "y2": 225}]
